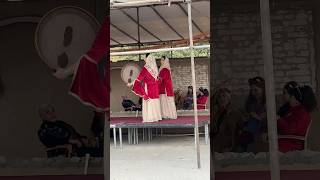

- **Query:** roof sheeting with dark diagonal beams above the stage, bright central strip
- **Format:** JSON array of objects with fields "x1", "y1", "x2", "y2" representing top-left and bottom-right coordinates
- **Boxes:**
[{"x1": 110, "y1": 1, "x2": 210, "y2": 46}]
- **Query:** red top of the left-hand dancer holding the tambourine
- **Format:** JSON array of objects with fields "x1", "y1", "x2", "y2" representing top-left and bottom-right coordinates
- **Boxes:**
[{"x1": 132, "y1": 67, "x2": 159, "y2": 100}]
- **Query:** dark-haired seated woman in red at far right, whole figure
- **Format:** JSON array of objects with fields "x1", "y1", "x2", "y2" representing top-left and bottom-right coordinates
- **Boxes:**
[{"x1": 277, "y1": 81, "x2": 317, "y2": 153}]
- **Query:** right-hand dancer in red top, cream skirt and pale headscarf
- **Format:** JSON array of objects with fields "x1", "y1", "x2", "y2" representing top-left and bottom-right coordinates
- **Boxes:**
[{"x1": 159, "y1": 56, "x2": 177, "y2": 119}]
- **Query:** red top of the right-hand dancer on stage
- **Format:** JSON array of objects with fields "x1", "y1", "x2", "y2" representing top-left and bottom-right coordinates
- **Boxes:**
[{"x1": 159, "y1": 68, "x2": 174, "y2": 97}]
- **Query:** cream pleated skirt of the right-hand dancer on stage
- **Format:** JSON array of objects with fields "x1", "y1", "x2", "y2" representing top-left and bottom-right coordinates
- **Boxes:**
[{"x1": 160, "y1": 94, "x2": 177, "y2": 119}]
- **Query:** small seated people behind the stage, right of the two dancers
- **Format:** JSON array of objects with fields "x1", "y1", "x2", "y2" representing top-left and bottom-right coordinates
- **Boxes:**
[{"x1": 174, "y1": 86, "x2": 209, "y2": 110}]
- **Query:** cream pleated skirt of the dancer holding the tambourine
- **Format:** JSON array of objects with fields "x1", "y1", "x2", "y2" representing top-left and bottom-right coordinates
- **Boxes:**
[{"x1": 142, "y1": 99, "x2": 162, "y2": 122}]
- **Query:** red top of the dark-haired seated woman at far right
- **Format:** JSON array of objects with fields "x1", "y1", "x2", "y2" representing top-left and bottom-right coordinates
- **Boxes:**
[{"x1": 277, "y1": 105, "x2": 311, "y2": 153}]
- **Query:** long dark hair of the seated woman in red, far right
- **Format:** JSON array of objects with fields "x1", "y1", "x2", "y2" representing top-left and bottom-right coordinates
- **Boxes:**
[{"x1": 284, "y1": 81, "x2": 318, "y2": 112}]
